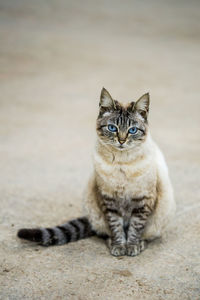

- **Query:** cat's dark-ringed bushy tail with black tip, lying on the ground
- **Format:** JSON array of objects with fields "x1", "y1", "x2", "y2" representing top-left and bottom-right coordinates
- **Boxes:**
[{"x1": 17, "y1": 217, "x2": 95, "y2": 246}]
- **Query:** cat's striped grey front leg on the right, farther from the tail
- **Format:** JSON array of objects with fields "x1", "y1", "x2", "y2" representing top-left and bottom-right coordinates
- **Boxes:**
[{"x1": 126, "y1": 205, "x2": 152, "y2": 256}]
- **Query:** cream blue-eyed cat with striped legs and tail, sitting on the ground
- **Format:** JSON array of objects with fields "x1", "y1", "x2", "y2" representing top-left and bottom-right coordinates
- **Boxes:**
[{"x1": 18, "y1": 88, "x2": 175, "y2": 256}]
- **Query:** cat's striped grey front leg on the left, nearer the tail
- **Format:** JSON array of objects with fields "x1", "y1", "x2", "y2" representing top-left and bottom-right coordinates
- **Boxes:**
[{"x1": 106, "y1": 210, "x2": 126, "y2": 256}]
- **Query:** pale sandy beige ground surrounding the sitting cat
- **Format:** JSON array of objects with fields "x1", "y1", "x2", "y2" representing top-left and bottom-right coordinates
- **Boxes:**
[{"x1": 0, "y1": 0, "x2": 200, "y2": 300}]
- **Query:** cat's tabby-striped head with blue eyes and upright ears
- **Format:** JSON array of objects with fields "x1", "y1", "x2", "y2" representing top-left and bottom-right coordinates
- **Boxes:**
[{"x1": 97, "y1": 88, "x2": 149, "y2": 150}]
